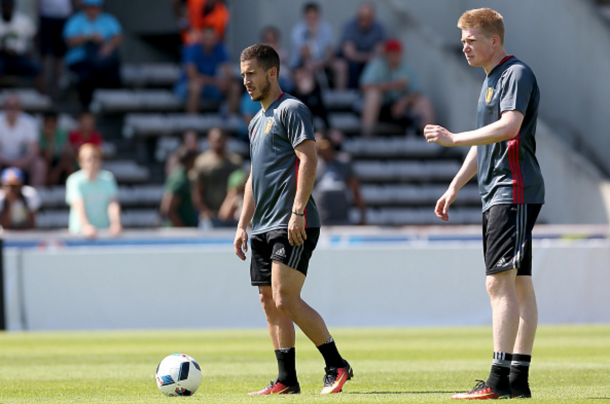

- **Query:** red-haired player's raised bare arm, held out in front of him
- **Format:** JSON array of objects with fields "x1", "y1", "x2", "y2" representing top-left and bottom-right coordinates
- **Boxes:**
[{"x1": 424, "y1": 111, "x2": 523, "y2": 147}]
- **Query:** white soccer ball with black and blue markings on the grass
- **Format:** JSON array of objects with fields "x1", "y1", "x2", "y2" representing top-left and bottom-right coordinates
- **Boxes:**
[{"x1": 155, "y1": 354, "x2": 201, "y2": 397}]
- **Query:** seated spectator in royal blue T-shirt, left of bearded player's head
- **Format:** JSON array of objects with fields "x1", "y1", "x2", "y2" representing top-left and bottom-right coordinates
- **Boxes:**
[{"x1": 174, "y1": 27, "x2": 241, "y2": 114}]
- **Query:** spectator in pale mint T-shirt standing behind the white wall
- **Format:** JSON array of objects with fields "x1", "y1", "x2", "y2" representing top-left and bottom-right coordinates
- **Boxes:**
[{"x1": 66, "y1": 143, "x2": 123, "y2": 238}]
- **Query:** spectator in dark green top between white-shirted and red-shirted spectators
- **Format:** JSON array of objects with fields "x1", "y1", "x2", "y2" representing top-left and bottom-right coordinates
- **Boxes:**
[{"x1": 38, "y1": 112, "x2": 76, "y2": 186}]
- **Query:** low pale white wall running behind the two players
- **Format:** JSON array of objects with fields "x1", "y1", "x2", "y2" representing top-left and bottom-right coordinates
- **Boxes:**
[{"x1": 4, "y1": 239, "x2": 610, "y2": 331}]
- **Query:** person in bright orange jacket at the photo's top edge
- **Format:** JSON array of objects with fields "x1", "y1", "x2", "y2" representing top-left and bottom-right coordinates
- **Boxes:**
[{"x1": 173, "y1": 0, "x2": 231, "y2": 45}]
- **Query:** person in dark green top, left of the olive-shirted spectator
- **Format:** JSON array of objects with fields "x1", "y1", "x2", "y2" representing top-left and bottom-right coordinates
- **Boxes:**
[{"x1": 160, "y1": 147, "x2": 198, "y2": 227}]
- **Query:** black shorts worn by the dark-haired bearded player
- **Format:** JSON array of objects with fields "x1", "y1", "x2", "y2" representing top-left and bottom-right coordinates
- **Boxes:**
[{"x1": 250, "y1": 227, "x2": 320, "y2": 286}]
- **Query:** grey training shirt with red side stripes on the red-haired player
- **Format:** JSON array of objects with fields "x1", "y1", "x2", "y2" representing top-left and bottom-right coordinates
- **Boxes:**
[{"x1": 477, "y1": 56, "x2": 544, "y2": 211}]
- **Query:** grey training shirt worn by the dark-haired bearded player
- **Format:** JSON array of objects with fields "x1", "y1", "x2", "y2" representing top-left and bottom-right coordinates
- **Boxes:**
[{"x1": 248, "y1": 93, "x2": 320, "y2": 234}]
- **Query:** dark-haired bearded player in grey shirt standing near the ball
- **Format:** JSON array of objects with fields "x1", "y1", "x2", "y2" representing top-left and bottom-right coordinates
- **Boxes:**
[{"x1": 233, "y1": 44, "x2": 353, "y2": 395}]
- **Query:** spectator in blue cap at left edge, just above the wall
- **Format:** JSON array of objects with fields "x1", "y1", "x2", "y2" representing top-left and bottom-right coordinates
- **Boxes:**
[{"x1": 0, "y1": 167, "x2": 42, "y2": 230}]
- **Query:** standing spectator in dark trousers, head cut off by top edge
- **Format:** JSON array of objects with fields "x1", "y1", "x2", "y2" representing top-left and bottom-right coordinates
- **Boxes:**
[{"x1": 38, "y1": 0, "x2": 73, "y2": 94}]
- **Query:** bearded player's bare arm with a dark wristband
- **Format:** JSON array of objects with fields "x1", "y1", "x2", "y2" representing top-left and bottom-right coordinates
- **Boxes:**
[{"x1": 288, "y1": 139, "x2": 318, "y2": 246}]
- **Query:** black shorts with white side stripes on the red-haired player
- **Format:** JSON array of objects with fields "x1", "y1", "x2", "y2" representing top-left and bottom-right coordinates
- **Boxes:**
[{"x1": 483, "y1": 204, "x2": 542, "y2": 276}]
